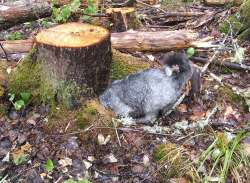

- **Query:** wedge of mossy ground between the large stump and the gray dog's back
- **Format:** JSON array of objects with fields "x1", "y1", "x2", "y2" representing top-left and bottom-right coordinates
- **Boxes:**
[{"x1": 110, "y1": 50, "x2": 149, "y2": 80}]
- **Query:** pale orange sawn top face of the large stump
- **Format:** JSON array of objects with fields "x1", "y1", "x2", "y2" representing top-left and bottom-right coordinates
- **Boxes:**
[{"x1": 36, "y1": 23, "x2": 109, "y2": 48}]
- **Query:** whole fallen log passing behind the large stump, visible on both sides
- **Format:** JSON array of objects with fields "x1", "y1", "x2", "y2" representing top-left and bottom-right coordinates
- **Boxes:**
[{"x1": 0, "y1": 30, "x2": 213, "y2": 55}]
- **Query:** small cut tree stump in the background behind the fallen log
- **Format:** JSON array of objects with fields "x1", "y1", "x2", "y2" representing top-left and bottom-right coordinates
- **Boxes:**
[{"x1": 106, "y1": 7, "x2": 140, "y2": 32}]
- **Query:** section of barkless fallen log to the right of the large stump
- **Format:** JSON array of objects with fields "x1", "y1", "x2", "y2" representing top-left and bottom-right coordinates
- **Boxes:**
[{"x1": 111, "y1": 30, "x2": 203, "y2": 51}]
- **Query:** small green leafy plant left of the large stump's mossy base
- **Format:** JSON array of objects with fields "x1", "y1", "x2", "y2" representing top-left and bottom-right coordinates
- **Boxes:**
[{"x1": 9, "y1": 92, "x2": 31, "y2": 111}]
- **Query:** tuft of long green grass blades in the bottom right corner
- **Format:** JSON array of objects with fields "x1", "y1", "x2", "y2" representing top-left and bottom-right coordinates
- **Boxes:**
[{"x1": 198, "y1": 131, "x2": 250, "y2": 183}]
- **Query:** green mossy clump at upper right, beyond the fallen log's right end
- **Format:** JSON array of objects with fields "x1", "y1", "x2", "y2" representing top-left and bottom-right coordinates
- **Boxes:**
[{"x1": 219, "y1": 14, "x2": 243, "y2": 34}]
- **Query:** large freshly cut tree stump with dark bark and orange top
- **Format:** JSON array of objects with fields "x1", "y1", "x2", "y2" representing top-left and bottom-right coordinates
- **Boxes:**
[{"x1": 34, "y1": 23, "x2": 112, "y2": 94}]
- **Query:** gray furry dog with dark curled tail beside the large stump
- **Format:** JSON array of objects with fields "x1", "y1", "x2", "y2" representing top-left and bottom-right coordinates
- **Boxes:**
[{"x1": 99, "y1": 53, "x2": 193, "y2": 123}]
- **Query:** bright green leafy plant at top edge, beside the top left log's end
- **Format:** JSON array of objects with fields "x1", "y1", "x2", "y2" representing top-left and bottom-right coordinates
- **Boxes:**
[{"x1": 52, "y1": 0, "x2": 81, "y2": 23}]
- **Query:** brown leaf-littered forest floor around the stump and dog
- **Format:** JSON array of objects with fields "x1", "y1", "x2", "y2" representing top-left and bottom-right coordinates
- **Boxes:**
[{"x1": 0, "y1": 0, "x2": 250, "y2": 183}]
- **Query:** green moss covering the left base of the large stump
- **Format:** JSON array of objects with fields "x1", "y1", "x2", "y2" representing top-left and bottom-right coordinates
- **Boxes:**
[{"x1": 8, "y1": 54, "x2": 81, "y2": 108}]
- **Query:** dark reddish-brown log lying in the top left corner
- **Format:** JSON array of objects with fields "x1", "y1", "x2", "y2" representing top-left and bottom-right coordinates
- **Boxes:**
[{"x1": 0, "y1": 1, "x2": 51, "y2": 30}]
